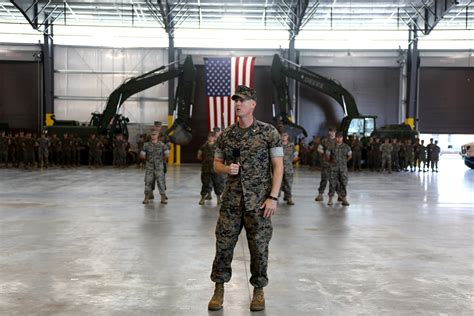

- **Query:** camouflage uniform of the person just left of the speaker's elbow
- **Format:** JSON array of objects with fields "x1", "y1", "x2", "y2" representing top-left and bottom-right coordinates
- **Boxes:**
[{"x1": 198, "y1": 142, "x2": 225, "y2": 196}]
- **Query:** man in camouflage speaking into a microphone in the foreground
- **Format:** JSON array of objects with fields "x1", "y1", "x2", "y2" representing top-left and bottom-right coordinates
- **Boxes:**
[{"x1": 208, "y1": 86, "x2": 283, "y2": 311}]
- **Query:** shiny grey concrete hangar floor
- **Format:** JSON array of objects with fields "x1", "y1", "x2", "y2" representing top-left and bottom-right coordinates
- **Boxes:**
[{"x1": 0, "y1": 158, "x2": 474, "y2": 316}]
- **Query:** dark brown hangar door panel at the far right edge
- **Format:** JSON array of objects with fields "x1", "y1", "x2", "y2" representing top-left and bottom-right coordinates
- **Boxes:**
[{"x1": 418, "y1": 67, "x2": 474, "y2": 134}]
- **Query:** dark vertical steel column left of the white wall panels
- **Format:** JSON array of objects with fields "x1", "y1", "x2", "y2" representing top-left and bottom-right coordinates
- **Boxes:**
[{"x1": 41, "y1": 22, "x2": 54, "y2": 127}]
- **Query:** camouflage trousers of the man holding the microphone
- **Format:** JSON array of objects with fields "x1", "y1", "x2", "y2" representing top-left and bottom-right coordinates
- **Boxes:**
[{"x1": 211, "y1": 199, "x2": 273, "y2": 287}]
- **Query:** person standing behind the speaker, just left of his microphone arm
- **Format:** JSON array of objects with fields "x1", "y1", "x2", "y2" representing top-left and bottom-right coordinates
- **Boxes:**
[{"x1": 197, "y1": 132, "x2": 224, "y2": 205}]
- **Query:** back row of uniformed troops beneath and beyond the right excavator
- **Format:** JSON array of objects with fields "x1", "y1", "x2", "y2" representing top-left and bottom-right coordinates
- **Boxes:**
[{"x1": 299, "y1": 136, "x2": 440, "y2": 173}]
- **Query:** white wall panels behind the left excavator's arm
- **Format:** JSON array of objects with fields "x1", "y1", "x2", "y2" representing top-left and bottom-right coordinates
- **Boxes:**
[{"x1": 55, "y1": 46, "x2": 168, "y2": 123}]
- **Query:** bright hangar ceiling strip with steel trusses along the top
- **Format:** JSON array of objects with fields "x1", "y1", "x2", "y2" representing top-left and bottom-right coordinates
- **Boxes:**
[{"x1": 0, "y1": 0, "x2": 474, "y2": 31}]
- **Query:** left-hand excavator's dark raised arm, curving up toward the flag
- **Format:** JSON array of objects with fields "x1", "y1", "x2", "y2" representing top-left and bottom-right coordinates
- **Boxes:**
[{"x1": 95, "y1": 56, "x2": 196, "y2": 144}]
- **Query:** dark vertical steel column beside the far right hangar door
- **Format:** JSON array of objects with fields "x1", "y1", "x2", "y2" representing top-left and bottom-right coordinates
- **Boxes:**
[{"x1": 406, "y1": 24, "x2": 420, "y2": 129}]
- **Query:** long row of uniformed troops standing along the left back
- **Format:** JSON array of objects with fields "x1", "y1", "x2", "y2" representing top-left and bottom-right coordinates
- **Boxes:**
[{"x1": 0, "y1": 131, "x2": 130, "y2": 169}]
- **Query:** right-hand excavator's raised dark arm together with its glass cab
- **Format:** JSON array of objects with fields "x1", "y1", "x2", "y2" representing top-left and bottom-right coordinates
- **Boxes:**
[{"x1": 271, "y1": 54, "x2": 375, "y2": 135}]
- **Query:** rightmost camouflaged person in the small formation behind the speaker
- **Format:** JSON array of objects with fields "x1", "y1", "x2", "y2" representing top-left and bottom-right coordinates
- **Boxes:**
[{"x1": 325, "y1": 132, "x2": 352, "y2": 206}]
